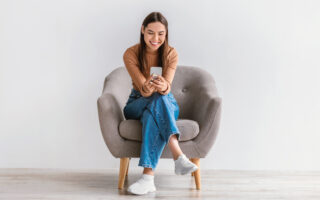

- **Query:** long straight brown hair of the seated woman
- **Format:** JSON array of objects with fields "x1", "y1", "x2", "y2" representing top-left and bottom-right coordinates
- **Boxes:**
[{"x1": 139, "y1": 12, "x2": 169, "y2": 74}]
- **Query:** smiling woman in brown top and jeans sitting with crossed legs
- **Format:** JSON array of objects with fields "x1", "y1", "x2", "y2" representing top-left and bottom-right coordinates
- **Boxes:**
[{"x1": 123, "y1": 12, "x2": 198, "y2": 194}]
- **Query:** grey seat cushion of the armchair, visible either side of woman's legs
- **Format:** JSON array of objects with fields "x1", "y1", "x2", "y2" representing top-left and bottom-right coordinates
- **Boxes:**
[{"x1": 119, "y1": 119, "x2": 199, "y2": 142}]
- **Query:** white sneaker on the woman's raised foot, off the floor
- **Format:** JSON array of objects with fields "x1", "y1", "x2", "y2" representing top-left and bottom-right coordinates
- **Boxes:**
[{"x1": 174, "y1": 154, "x2": 198, "y2": 175}]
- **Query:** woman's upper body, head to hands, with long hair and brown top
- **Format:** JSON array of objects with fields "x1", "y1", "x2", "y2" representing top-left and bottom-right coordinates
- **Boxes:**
[{"x1": 123, "y1": 12, "x2": 178, "y2": 97}]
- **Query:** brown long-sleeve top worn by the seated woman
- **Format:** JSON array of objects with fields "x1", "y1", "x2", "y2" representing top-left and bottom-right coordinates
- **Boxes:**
[{"x1": 123, "y1": 43, "x2": 178, "y2": 97}]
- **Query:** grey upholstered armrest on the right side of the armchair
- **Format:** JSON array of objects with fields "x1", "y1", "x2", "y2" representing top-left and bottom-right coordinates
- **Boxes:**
[{"x1": 192, "y1": 88, "x2": 222, "y2": 157}]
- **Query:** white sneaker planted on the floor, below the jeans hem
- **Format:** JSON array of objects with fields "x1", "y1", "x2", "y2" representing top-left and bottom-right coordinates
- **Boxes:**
[{"x1": 127, "y1": 174, "x2": 156, "y2": 195}]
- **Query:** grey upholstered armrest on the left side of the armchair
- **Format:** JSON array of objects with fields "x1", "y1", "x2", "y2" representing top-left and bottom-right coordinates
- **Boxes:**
[{"x1": 97, "y1": 93, "x2": 125, "y2": 157}]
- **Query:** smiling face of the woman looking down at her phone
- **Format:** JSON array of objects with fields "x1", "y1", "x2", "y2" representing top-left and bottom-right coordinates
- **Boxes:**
[{"x1": 141, "y1": 22, "x2": 166, "y2": 51}]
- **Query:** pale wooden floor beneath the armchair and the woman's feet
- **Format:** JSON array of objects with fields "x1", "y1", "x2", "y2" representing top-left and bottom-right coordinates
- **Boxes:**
[{"x1": 0, "y1": 169, "x2": 320, "y2": 200}]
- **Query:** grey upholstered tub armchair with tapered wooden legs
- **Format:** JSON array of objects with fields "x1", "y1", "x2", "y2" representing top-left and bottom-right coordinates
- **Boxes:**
[{"x1": 97, "y1": 66, "x2": 222, "y2": 189}]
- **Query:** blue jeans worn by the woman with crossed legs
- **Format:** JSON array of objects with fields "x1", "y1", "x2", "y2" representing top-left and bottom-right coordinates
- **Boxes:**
[{"x1": 123, "y1": 88, "x2": 180, "y2": 170}]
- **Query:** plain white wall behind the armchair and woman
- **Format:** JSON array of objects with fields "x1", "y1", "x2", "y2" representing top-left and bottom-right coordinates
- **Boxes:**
[{"x1": 0, "y1": 0, "x2": 320, "y2": 170}]
